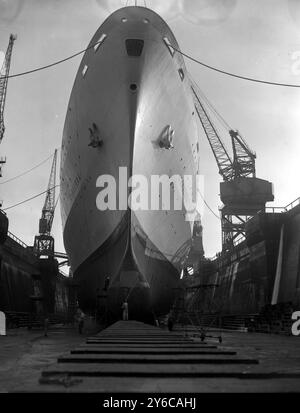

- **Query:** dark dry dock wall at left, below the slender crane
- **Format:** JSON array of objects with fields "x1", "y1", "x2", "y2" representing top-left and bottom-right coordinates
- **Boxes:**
[{"x1": 0, "y1": 234, "x2": 70, "y2": 316}]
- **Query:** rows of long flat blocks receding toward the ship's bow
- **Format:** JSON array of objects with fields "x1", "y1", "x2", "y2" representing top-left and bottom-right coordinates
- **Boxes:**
[{"x1": 34, "y1": 321, "x2": 300, "y2": 393}]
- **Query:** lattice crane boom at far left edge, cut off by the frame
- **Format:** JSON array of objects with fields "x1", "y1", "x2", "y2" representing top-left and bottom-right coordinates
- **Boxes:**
[{"x1": 0, "y1": 34, "x2": 17, "y2": 142}]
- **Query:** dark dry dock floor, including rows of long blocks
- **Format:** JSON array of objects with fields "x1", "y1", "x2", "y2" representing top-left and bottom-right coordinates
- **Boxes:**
[{"x1": 0, "y1": 321, "x2": 300, "y2": 393}]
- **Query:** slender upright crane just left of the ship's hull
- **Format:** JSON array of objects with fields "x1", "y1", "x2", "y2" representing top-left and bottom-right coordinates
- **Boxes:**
[{"x1": 34, "y1": 149, "x2": 57, "y2": 257}]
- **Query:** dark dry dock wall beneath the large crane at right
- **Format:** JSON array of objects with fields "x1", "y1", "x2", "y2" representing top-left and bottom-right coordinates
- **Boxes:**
[{"x1": 198, "y1": 205, "x2": 300, "y2": 315}]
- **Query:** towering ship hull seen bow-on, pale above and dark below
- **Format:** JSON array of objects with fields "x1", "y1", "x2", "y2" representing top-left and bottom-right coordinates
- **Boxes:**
[{"x1": 61, "y1": 7, "x2": 199, "y2": 319}]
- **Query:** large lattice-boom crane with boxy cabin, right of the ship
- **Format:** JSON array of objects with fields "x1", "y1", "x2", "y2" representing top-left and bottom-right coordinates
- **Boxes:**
[{"x1": 191, "y1": 80, "x2": 274, "y2": 252}]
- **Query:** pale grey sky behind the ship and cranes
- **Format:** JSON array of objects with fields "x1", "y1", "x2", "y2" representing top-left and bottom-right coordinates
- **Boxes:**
[{"x1": 0, "y1": 0, "x2": 300, "y2": 264}]
